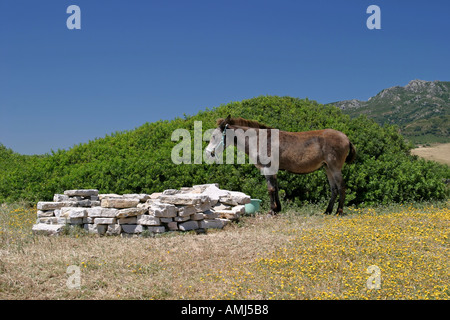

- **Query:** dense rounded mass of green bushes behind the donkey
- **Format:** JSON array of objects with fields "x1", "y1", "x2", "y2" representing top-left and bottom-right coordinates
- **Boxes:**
[{"x1": 0, "y1": 96, "x2": 450, "y2": 205}]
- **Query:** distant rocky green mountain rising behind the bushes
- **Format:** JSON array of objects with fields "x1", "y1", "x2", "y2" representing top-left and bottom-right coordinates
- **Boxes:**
[{"x1": 330, "y1": 80, "x2": 450, "y2": 143}]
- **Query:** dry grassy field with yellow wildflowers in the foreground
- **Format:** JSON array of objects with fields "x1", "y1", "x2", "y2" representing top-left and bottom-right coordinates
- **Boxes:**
[{"x1": 0, "y1": 202, "x2": 450, "y2": 299}]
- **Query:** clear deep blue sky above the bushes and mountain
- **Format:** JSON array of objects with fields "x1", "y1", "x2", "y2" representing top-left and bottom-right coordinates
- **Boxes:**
[{"x1": 0, "y1": 0, "x2": 450, "y2": 154}]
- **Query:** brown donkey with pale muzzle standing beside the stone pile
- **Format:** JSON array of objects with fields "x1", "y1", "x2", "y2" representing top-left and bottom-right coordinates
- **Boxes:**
[{"x1": 205, "y1": 116, "x2": 356, "y2": 215}]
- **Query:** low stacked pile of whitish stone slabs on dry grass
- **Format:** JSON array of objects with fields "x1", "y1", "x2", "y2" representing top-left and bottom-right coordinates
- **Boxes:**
[{"x1": 32, "y1": 184, "x2": 250, "y2": 236}]
